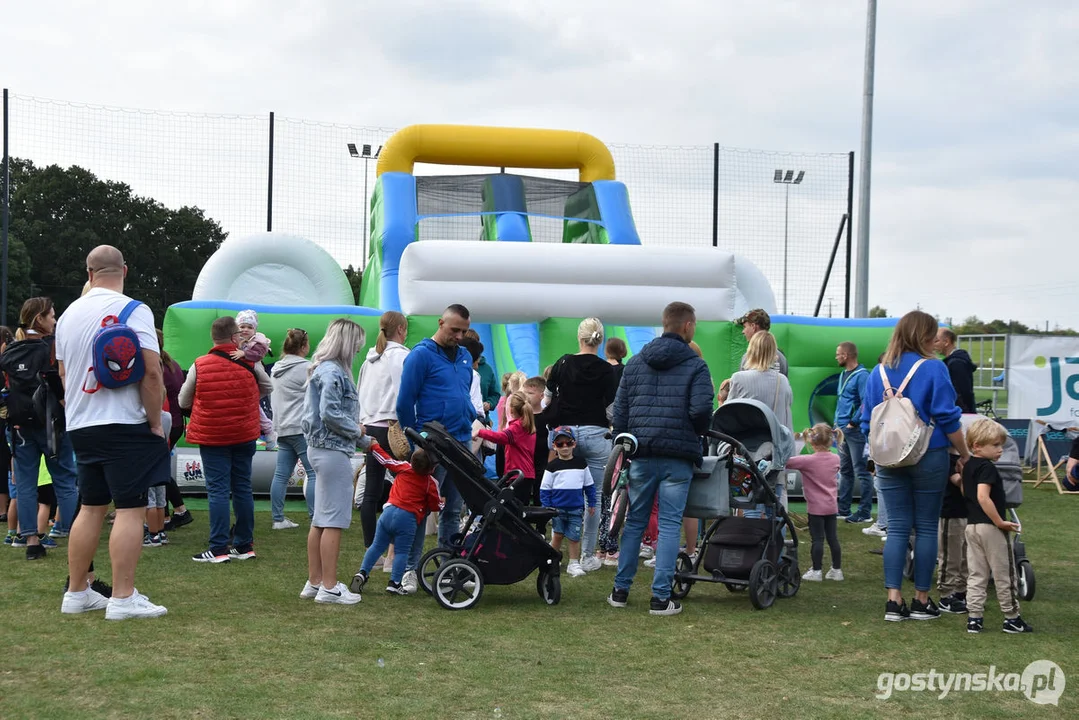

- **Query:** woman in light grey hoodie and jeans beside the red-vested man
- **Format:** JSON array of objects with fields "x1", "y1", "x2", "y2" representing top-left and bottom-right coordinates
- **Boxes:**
[{"x1": 270, "y1": 328, "x2": 315, "y2": 530}]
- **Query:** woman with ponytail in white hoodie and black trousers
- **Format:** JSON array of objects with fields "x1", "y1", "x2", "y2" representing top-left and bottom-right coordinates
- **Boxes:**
[{"x1": 359, "y1": 310, "x2": 409, "y2": 547}]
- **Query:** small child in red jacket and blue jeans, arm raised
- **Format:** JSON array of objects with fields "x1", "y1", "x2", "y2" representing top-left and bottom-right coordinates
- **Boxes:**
[{"x1": 350, "y1": 440, "x2": 446, "y2": 595}]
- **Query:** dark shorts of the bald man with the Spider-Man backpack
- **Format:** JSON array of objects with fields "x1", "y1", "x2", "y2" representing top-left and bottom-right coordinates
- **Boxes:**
[{"x1": 68, "y1": 423, "x2": 169, "y2": 510}]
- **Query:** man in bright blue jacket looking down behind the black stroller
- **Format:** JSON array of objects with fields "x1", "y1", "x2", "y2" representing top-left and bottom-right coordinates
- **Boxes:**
[{"x1": 397, "y1": 304, "x2": 476, "y2": 593}]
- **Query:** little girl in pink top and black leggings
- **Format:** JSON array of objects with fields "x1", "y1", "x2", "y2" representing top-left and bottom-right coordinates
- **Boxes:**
[{"x1": 787, "y1": 422, "x2": 843, "y2": 582}]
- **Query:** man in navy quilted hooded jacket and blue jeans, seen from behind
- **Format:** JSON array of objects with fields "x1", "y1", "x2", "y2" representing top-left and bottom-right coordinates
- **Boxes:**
[{"x1": 607, "y1": 302, "x2": 712, "y2": 615}]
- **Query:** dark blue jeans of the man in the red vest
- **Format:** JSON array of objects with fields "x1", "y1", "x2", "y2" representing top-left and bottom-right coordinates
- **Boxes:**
[{"x1": 199, "y1": 440, "x2": 255, "y2": 553}]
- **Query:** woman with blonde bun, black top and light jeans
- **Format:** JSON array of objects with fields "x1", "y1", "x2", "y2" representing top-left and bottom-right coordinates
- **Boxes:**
[{"x1": 548, "y1": 317, "x2": 618, "y2": 572}]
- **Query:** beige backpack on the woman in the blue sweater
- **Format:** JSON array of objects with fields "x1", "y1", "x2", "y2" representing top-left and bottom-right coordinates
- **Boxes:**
[{"x1": 870, "y1": 358, "x2": 933, "y2": 467}]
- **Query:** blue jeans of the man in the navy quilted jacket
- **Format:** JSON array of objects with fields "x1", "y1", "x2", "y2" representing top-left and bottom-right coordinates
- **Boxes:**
[{"x1": 617, "y1": 458, "x2": 693, "y2": 600}]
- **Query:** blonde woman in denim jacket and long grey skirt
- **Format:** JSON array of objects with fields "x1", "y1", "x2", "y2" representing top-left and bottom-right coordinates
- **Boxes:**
[{"x1": 300, "y1": 317, "x2": 366, "y2": 604}]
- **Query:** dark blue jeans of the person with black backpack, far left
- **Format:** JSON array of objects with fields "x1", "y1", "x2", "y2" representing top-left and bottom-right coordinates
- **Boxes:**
[{"x1": 11, "y1": 427, "x2": 79, "y2": 536}]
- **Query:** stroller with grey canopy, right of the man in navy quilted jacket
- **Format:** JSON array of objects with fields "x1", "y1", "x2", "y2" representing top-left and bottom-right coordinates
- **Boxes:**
[{"x1": 671, "y1": 400, "x2": 802, "y2": 610}]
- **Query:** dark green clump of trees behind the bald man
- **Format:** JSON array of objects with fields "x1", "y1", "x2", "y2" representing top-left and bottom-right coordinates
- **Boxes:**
[{"x1": 9, "y1": 159, "x2": 227, "y2": 321}]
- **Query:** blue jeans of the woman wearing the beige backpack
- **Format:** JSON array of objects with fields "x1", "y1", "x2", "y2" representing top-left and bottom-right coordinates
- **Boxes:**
[{"x1": 877, "y1": 448, "x2": 948, "y2": 590}]
